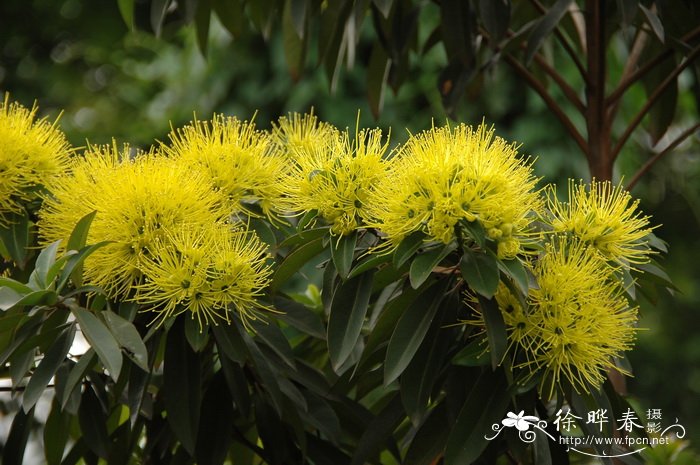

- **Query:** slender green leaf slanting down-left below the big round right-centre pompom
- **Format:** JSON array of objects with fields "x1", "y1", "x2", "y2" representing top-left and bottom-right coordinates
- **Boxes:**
[{"x1": 384, "y1": 284, "x2": 445, "y2": 385}]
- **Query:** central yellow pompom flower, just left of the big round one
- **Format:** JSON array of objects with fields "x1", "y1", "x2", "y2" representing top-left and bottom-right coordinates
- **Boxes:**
[{"x1": 286, "y1": 129, "x2": 388, "y2": 235}]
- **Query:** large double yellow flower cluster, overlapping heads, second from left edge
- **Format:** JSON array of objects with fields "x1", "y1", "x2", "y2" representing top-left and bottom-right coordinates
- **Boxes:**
[{"x1": 39, "y1": 145, "x2": 269, "y2": 323}]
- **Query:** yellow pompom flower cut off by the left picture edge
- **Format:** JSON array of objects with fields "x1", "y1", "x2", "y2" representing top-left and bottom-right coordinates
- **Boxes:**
[{"x1": 0, "y1": 94, "x2": 71, "y2": 225}]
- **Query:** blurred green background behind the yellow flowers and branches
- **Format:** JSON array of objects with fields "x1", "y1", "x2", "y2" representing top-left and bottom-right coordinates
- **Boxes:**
[{"x1": 0, "y1": 0, "x2": 700, "y2": 447}]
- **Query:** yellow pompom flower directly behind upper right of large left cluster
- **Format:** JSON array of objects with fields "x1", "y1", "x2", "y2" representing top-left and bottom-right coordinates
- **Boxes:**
[{"x1": 162, "y1": 115, "x2": 287, "y2": 217}]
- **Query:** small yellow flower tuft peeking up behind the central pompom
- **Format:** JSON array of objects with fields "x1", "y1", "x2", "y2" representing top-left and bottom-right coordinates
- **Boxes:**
[{"x1": 272, "y1": 112, "x2": 339, "y2": 160}]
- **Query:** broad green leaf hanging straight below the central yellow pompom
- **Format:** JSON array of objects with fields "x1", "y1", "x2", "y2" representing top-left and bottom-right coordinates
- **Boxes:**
[{"x1": 327, "y1": 272, "x2": 373, "y2": 370}]
